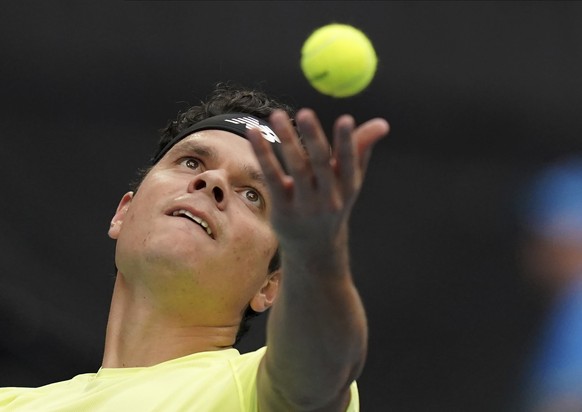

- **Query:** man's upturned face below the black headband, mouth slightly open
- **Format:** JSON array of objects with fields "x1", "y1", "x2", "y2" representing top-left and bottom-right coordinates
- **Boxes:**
[{"x1": 109, "y1": 130, "x2": 277, "y2": 322}]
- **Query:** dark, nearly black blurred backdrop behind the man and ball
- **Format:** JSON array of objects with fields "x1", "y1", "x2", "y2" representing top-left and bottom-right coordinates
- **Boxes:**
[{"x1": 0, "y1": 1, "x2": 582, "y2": 411}]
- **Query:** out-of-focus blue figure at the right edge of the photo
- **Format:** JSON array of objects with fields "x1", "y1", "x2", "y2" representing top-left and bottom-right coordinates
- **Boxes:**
[{"x1": 521, "y1": 158, "x2": 582, "y2": 412}]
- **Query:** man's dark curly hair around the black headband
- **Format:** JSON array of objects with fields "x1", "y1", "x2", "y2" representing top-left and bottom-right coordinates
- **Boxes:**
[{"x1": 144, "y1": 83, "x2": 295, "y2": 345}]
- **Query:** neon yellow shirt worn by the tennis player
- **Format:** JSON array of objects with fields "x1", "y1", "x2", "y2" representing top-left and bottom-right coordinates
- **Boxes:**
[{"x1": 0, "y1": 348, "x2": 359, "y2": 412}]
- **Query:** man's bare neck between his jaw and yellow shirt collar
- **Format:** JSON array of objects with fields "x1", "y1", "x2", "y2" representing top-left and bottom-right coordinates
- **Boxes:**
[{"x1": 103, "y1": 272, "x2": 239, "y2": 368}]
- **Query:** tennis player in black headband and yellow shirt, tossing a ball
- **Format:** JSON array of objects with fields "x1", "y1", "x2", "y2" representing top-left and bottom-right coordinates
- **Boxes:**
[{"x1": 0, "y1": 87, "x2": 388, "y2": 412}]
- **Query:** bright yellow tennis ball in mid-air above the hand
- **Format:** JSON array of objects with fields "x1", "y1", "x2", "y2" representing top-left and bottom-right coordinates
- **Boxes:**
[{"x1": 301, "y1": 24, "x2": 378, "y2": 97}]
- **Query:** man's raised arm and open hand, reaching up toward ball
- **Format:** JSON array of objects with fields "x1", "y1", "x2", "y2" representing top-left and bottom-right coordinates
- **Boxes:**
[{"x1": 249, "y1": 109, "x2": 389, "y2": 411}]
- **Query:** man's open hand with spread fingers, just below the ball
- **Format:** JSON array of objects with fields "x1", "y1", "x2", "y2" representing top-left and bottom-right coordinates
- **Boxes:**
[{"x1": 249, "y1": 109, "x2": 389, "y2": 258}]
